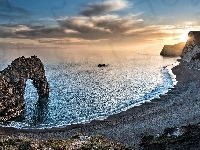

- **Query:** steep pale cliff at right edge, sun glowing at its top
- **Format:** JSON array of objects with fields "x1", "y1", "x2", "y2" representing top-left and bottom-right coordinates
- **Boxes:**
[{"x1": 181, "y1": 31, "x2": 200, "y2": 62}]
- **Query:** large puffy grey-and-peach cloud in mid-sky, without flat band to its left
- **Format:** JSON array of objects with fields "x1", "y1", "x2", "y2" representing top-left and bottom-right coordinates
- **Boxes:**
[{"x1": 58, "y1": 15, "x2": 143, "y2": 39}]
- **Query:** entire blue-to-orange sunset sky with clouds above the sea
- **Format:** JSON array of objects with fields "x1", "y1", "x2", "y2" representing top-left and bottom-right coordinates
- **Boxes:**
[{"x1": 0, "y1": 0, "x2": 200, "y2": 58}]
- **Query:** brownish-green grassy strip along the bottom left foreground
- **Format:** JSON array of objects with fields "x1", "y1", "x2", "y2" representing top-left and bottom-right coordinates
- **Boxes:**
[{"x1": 0, "y1": 134, "x2": 134, "y2": 150}]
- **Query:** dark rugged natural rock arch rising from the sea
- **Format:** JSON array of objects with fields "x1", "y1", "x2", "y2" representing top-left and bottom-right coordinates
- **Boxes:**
[{"x1": 0, "y1": 56, "x2": 49, "y2": 123}]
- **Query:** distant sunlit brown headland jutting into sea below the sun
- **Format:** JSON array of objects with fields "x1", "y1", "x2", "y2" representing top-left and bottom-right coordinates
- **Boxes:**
[{"x1": 160, "y1": 42, "x2": 185, "y2": 57}]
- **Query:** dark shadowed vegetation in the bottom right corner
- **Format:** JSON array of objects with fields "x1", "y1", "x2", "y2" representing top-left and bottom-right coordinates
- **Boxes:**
[{"x1": 141, "y1": 124, "x2": 200, "y2": 150}]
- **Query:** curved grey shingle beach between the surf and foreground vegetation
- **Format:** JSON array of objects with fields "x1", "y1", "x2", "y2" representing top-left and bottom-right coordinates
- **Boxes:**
[{"x1": 0, "y1": 60, "x2": 200, "y2": 147}]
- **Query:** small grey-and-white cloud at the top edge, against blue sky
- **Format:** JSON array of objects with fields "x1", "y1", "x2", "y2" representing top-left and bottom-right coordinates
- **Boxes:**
[{"x1": 80, "y1": 0, "x2": 130, "y2": 16}]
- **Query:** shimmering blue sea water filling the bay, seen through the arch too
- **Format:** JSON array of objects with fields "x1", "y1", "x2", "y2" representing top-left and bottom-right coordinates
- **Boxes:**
[{"x1": 0, "y1": 55, "x2": 177, "y2": 128}]
